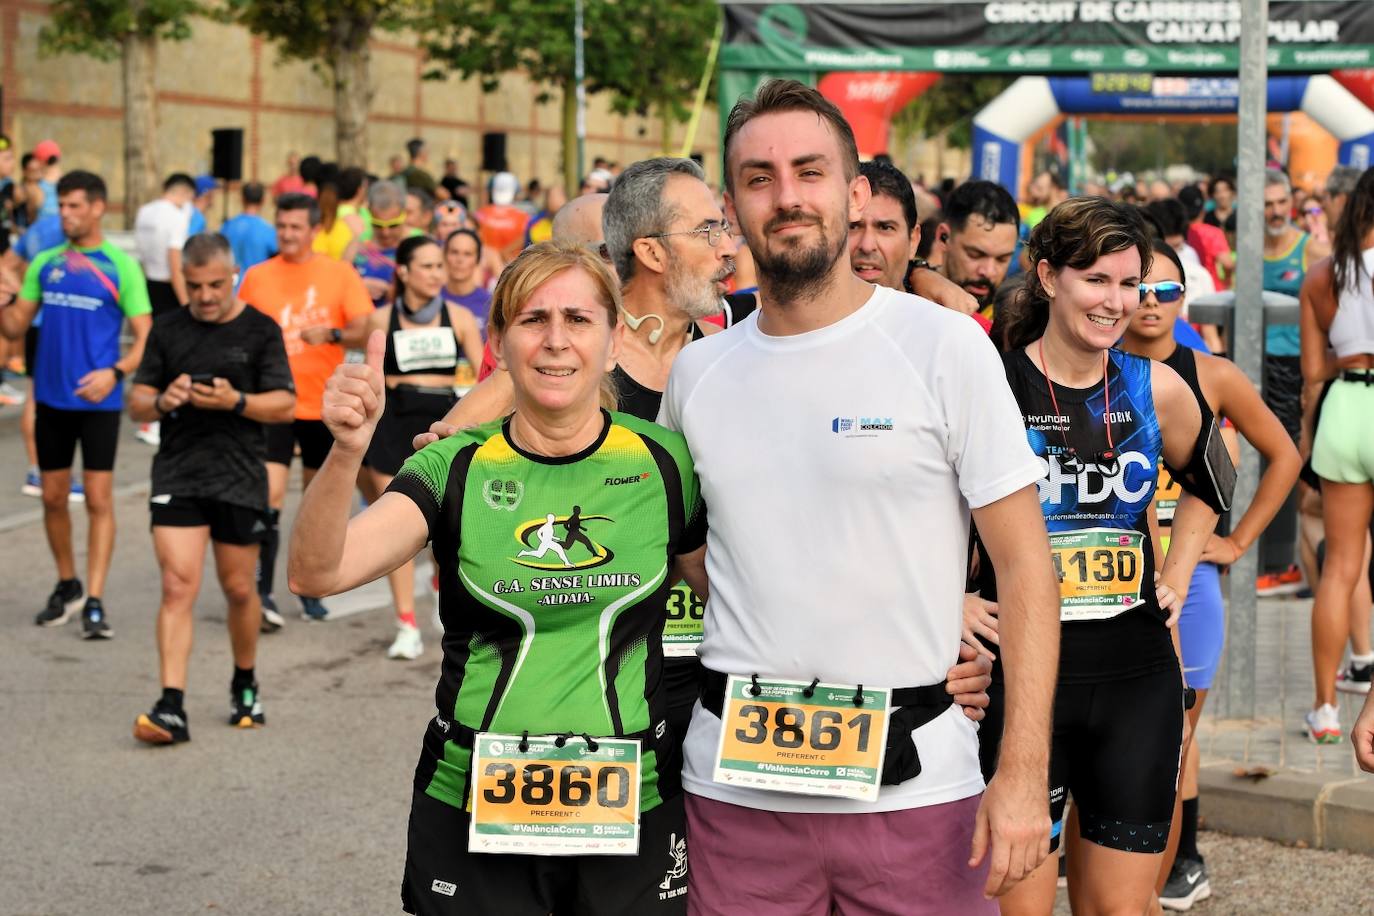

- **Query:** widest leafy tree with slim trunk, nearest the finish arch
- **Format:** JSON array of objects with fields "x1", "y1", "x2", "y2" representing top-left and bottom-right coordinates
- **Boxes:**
[{"x1": 422, "y1": 0, "x2": 720, "y2": 192}]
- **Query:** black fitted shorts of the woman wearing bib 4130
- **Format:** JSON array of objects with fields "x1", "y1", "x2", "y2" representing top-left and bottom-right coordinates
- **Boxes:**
[{"x1": 978, "y1": 669, "x2": 1183, "y2": 853}]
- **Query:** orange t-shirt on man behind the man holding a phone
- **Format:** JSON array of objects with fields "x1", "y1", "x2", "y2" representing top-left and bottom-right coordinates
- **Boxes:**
[{"x1": 239, "y1": 254, "x2": 372, "y2": 420}]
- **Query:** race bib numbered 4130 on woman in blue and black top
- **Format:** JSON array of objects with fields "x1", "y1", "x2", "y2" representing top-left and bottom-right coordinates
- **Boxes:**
[{"x1": 1050, "y1": 527, "x2": 1145, "y2": 622}]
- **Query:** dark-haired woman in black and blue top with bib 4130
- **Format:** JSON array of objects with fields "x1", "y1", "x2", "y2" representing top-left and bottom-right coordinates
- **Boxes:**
[{"x1": 981, "y1": 198, "x2": 1216, "y2": 915}]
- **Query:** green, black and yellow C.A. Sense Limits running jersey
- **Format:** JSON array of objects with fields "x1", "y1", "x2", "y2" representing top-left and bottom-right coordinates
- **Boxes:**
[{"x1": 387, "y1": 411, "x2": 706, "y2": 810}]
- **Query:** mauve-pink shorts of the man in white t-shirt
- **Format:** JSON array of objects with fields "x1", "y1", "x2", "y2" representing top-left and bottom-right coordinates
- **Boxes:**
[{"x1": 687, "y1": 794, "x2": 998, "y2": 916}]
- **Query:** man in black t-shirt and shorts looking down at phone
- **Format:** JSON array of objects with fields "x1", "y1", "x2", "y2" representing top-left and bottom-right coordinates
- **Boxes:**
[{"x1": 129, "y1": 233, "x2": 295, "y2": 744}]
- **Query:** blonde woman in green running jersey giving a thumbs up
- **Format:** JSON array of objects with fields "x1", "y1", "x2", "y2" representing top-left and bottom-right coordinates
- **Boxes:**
[{"x1": 290, "y1": 243, "x2": 705, "y2": 913}]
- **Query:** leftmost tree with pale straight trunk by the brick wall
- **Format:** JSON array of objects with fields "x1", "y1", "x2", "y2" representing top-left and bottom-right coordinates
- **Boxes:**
[{"x1": 38, "y1": 0, "x2": 201, "y2": 227}]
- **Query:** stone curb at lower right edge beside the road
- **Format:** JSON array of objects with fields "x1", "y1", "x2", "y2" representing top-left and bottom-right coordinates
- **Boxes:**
[{"x1": 1198, "y1": 764, "x2": 1374, "y2": 856}]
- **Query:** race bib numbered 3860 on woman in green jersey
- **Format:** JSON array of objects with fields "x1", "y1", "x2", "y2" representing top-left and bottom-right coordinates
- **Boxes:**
[{"x1": 467, "y1": 732, "x2": 640, "y2": 856}]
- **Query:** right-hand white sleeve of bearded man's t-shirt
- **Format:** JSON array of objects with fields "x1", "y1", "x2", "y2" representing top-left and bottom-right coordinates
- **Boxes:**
[{"x1": 932, "y1": 323, "x2": 1041, "y2": 508}]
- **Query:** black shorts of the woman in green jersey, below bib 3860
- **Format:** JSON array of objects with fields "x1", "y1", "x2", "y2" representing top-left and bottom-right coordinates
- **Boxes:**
[{"x1": 401, "y1": 791, "x2": 687, "y2": 916}]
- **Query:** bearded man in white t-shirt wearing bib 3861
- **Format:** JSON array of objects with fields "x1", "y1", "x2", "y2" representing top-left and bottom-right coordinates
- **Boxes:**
[{"x1": 660, "y1": 81, "x2": 1058, "y2": 916}]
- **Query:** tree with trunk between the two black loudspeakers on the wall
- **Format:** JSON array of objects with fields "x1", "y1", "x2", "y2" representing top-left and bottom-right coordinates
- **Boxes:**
[{"x1": 227, "y1": 0, "x2": 417, "y2": 169}]
